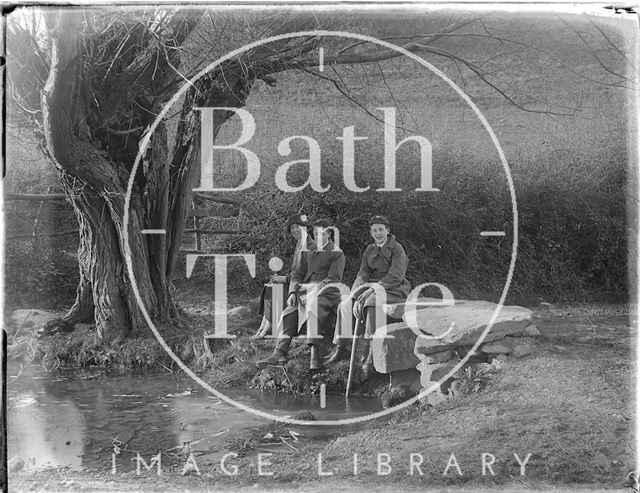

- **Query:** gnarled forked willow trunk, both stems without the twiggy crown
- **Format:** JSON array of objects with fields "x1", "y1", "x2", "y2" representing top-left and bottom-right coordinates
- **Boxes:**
[{"x1": 42, "y1": 13, "x2": 250, "y2": 339}]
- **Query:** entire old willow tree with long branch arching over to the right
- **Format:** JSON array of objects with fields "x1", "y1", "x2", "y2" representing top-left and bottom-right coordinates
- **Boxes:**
[{"x1": 8, "y1": 8, "x2": 632, "y2": 339}]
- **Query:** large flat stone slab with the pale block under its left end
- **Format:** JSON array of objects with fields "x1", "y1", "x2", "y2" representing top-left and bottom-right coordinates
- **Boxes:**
[{"x1": 372, "y1": 298, "x2": 532, "y2": 373}]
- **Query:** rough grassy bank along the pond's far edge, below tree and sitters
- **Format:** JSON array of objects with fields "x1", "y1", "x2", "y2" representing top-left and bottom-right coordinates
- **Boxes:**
[{"x1": 8, "y1": 299, "x2": 388, "y2": 395}]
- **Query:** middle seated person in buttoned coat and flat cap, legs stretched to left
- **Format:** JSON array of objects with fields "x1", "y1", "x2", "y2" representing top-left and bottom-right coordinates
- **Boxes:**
[{"x1": 257, "y1": 219, "x2": 345, "y2": 370}]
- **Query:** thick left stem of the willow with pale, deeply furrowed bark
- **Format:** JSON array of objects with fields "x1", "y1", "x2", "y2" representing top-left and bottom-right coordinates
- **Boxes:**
[{"x1": 42, "y1": 12, "x2": 157, "y2": 339}]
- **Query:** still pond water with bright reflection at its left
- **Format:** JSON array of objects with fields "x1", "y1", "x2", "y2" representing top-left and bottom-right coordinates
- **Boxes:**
[{"x1": 7, "y1": 370, "x2": 381, "y2": 471}]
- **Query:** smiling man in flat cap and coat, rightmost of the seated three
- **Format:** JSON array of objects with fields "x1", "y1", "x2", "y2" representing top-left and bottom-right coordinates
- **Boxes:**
[{"x1": 327, "y1": 215, "x2": 411, "y2": 378}]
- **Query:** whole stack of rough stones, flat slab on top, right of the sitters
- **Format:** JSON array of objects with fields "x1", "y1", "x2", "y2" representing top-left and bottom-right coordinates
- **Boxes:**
[{"x1": 373, "y1": 299, "x2": 539, "y2": 405}]
